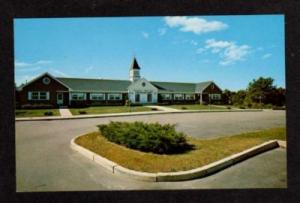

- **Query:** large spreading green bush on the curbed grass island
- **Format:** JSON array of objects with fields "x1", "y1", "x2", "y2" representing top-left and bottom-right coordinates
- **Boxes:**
[{"x1": 98, "y1": 122, "x2": 191, "y2": 154}]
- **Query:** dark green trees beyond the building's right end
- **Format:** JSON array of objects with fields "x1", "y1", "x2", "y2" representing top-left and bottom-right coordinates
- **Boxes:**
[{"x1": 222, "y1": 77, "x2": 286, "y2": 108}]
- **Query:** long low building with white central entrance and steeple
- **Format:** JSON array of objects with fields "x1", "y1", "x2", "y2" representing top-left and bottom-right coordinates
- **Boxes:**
[{"x1": 16, "y1": 58, "x2": 222, "y2": 108}]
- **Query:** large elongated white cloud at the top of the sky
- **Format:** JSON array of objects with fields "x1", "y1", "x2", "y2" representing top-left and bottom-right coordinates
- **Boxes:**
[{"x1": 164, "y1": 16, "x2": 228, "y2": 34}]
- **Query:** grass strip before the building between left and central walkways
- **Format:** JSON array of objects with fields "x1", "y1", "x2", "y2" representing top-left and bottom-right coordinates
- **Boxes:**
[{"x1": 70, "y1": 106, "x2": 156, "y2": 115}]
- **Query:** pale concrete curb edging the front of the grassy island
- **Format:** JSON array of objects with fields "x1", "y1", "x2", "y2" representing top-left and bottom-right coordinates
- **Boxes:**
[{"x1": 71, "y1": 135, "x2": 286, "y2": 182}]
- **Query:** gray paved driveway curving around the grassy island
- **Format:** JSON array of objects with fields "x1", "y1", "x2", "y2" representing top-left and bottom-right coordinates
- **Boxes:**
[{"x1": 16, "y1": 111, "x2": 286, "y2": 191}]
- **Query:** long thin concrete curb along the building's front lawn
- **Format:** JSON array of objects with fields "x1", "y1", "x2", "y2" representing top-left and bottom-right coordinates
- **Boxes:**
[{"x1": 15, "y1": 109, "x2": 262, "y2": 121}]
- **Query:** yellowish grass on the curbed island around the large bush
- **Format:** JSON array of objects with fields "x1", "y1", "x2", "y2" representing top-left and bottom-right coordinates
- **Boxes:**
[{"x1": 75, "y1": 128, "x2": 286, "y2": 172}]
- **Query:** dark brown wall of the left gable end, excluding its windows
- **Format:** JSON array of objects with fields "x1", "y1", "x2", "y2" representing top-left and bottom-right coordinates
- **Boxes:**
[{"x1": 18, "y1": 76, "x2": 68, "y2": 106}]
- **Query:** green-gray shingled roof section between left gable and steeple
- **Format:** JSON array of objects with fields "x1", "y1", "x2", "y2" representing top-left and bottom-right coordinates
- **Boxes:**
[{"x1": 56, "y1": 77, "x2": 131, "y2": 92}]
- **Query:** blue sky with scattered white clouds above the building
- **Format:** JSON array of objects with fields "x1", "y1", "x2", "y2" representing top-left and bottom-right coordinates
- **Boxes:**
[{"x1": 14, "y1": 15, "x2": 285, "y2": 91}]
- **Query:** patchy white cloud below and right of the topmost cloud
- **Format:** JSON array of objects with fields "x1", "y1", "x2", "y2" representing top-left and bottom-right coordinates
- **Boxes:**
[{"x1": 196, "y1": 39, "x2": 251, "y2": 66}]
